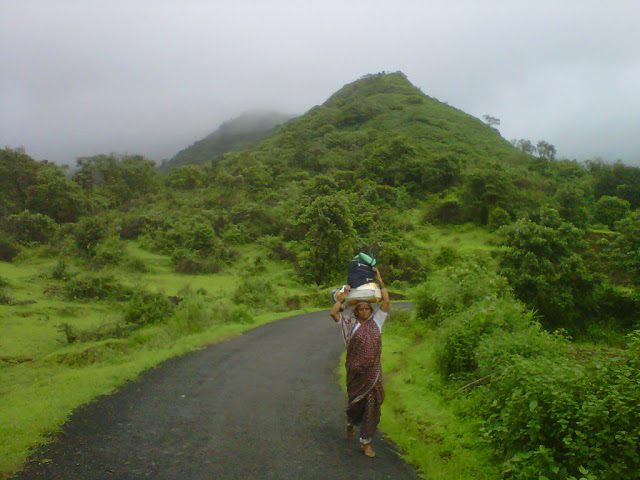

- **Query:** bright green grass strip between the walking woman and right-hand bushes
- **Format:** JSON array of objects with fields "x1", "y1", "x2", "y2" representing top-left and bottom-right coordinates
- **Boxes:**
[{"x1": 380, "y1": 326, "x2": 499, "y2": 480}]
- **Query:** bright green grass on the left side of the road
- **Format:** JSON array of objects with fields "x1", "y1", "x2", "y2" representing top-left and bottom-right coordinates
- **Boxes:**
[{"x1": 0, "y1": 243, "x2": 320, "y2": 478}]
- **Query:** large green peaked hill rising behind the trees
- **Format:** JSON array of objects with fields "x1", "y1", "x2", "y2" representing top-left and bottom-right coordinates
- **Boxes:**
[{"x1": 202, "y1": 73, "x2": 554, "y2": 224}]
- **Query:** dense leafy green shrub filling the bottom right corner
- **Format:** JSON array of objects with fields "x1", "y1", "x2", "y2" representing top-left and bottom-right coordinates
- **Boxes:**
[{"x1": 478, "y1": 352, "x2": 640, "y2": 480}]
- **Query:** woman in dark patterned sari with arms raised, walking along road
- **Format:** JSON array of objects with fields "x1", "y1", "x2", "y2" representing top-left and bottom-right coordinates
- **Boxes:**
[{"x1": 330, "y1": 268, "x2": 389, "y2": 457}]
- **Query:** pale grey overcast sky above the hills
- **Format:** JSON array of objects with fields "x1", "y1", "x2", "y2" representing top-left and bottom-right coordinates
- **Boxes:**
[{"x1": 0, "y1": 0, "x2": 640, "y2": 165}]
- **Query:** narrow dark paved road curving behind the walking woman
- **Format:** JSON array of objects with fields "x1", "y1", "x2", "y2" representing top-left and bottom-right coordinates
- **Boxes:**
[{"x1": 15, "y1": 312, "x2": 418, "y2": 480}]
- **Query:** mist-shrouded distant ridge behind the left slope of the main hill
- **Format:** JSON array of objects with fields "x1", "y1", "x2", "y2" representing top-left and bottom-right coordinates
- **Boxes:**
[{"x1": 160, "y1": 110, "x2": 294, "y2": 170}]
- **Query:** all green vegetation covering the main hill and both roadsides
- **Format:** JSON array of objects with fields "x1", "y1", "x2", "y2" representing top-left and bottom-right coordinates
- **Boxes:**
[{"x1": 0, "y1": 73, "x2": 640, "y2": 480}]
